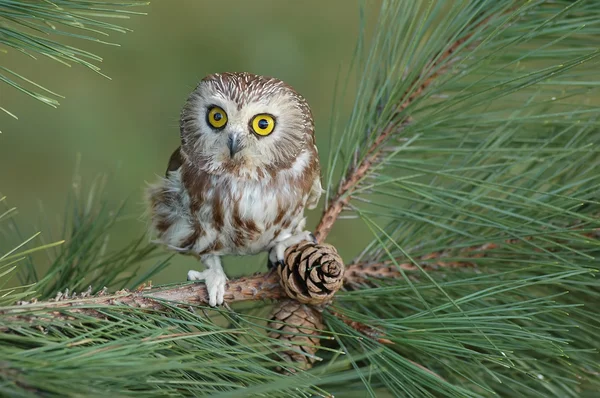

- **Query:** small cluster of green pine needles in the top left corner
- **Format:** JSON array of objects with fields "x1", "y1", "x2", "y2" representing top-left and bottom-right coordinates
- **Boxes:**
[{"x1": 0, "y1": 0, "x2": 148, "y2": 119}]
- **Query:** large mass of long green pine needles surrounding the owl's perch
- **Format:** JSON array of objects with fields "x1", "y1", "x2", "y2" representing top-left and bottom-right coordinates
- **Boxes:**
[{"x1": 0, "y1": 0, "x2": 600, "y2": 398}]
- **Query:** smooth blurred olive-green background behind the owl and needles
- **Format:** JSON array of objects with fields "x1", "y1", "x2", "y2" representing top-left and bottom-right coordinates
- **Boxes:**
[{"x1": 0, "y1": 0, "x2": 379, "y2": 283}]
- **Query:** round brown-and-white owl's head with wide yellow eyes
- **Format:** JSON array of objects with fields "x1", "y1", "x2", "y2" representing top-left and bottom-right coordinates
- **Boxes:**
[{"x1": 180, "y1": 73, "x2": 314, "y2": 174}]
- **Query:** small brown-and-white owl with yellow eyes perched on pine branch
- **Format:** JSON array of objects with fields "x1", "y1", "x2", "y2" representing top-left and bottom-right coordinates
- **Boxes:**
[{"x1": 147, "y1": 73, "x2": 322, "y2": 306}]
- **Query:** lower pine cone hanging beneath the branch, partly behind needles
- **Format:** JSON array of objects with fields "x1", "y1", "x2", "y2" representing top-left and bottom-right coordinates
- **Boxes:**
[{"x1": 269, "y1": 299, "x2": 323, "y2": 373}]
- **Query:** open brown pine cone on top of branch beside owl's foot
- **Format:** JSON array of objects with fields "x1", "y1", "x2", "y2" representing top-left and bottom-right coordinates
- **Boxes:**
[{"x1": 277, "y1": 241, "x2": 344, "y2": 305}]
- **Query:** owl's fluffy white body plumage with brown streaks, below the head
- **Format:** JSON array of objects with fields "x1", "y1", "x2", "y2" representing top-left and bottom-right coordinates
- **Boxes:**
[{"x1": 150, "y1": 151, "x2": 308, "y2": 255}]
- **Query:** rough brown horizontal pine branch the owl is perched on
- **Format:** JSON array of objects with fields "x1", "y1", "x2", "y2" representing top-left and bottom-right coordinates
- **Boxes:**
[{"x1": 8, "y1": 224, "x2": 600, "y2": 324}]
